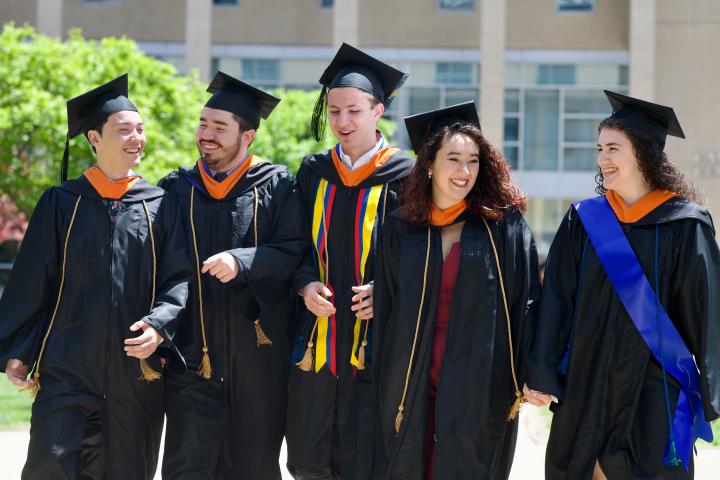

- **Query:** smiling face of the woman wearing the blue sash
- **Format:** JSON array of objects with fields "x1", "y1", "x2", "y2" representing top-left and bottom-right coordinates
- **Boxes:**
[{"x1": 597, "y1": 127, "x2": 650, "y2": 199}]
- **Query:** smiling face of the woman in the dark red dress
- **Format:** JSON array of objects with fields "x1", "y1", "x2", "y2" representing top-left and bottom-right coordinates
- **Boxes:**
[{"x1": 430, "y1": 133, "x2": 480, "y2": 210}]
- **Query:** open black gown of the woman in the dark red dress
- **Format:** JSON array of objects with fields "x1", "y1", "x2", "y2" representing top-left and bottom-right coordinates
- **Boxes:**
[{"x1": 373, "y1": 210, "x2": 540, "y2": 480}]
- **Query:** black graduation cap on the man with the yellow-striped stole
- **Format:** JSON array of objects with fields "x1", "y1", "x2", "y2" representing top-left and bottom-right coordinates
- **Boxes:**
[{"x1": 311, "y1": 43, "x2": 408, "y2": 141}]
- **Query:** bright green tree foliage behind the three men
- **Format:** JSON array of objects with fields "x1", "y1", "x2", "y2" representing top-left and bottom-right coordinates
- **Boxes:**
[{"x1": 0, "y1": 23, "x2": 394, "y2": 214}]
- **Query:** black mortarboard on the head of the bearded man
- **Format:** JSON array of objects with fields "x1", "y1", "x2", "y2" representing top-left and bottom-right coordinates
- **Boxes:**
[{"x1": 205, "y1": 71, "x2": 280, "y2": 129}]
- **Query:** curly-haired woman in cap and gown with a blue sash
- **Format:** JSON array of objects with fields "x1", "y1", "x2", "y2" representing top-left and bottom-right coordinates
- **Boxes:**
[{"x1": 528, "y1": 91, "x2": 720, "y2": 480}]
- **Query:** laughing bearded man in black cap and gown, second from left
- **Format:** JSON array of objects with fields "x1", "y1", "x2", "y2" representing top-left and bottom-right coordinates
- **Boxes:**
[{"x1": 160, "y1": 72, "x2": 306, "y2": 480}]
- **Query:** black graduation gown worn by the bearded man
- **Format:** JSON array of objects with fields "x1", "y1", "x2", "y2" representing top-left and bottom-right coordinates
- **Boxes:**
[{"x1": 160, "y1": 162, "x2": 307, "y2": 480}]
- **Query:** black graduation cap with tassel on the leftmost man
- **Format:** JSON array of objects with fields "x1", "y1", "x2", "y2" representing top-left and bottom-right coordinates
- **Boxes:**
[{"x1": 60, "y1": 73, "x2": 138, "y2": 182}]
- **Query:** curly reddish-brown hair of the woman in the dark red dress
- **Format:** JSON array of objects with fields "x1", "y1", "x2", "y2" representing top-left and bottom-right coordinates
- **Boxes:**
[{"x1": 403, "y1": 121, "x2": 527, "y2": 225}]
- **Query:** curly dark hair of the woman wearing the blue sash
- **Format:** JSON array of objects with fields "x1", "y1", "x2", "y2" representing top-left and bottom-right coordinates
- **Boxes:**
[{"x1": 595, "y1": 117, "x2": 702, "y2": 203}]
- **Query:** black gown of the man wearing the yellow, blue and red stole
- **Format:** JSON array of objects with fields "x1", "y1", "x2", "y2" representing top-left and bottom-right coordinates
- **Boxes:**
[{"x1": 287, "y1": 151, "x2": 414, "y2": 480}]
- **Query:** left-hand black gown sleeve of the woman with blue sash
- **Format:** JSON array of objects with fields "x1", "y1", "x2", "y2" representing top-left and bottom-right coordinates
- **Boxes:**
[{"x1": 527, "y1": 208, "x2": 584, "y2": 400}]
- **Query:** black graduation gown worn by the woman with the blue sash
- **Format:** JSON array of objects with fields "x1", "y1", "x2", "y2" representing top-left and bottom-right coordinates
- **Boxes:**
[{"x1": 528, "y1": 198, "x2": 720, "y2": 480}]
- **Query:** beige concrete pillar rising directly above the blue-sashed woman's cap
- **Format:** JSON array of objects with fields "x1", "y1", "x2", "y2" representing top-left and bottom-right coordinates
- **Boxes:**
[{"x1": 629, "y1": 0, "x2": 657, "y2": 101}]
